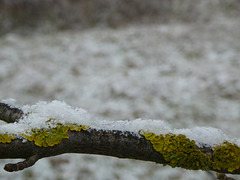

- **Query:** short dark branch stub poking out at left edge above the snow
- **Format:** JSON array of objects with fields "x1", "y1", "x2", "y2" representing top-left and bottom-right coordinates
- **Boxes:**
[{"x1": 0, "y1": 103, "x2": 24, "y2": 123}]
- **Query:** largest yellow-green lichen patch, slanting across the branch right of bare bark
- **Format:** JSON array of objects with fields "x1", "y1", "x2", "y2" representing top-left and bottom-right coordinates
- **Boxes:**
[{"x1": 143, "y1": 133, "x2": 212, "y2": 170}]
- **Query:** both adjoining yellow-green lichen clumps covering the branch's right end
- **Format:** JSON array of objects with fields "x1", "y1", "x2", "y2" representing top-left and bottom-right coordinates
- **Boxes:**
[{"x1": 142, "y1": 133, "x2": 240, "y2": 172}]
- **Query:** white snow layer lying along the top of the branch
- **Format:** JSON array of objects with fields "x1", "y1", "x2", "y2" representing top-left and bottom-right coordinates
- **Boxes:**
[{"x1": 0, "y1": 100, "x2": 237, "y2": 146}]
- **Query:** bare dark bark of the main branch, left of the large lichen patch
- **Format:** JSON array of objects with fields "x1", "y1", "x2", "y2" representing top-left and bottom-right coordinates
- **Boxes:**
[{"x1": 0, "y1": 129, "x2": 167, "y2": 171}]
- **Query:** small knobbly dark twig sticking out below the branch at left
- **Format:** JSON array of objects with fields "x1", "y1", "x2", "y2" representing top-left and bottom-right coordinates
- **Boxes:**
[{"x1": 4, "y1": 155, "x2": 39, "y2": 172}]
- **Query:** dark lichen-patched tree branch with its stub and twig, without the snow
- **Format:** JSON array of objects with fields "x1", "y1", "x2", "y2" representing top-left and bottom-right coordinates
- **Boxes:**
[{"x1": 0, "y1": 103, "x2": 240, "y2": 178}]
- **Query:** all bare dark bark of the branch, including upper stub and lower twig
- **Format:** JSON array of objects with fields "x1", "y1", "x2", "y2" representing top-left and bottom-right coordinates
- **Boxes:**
[{"x1": 0, "y1": 103, "x2": 240, "y2": 179}]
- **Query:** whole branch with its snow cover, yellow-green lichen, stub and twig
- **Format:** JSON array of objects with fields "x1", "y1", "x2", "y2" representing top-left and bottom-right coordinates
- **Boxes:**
[{"x1": 0, "y1": 101, "x2": 240, "y2": 177}]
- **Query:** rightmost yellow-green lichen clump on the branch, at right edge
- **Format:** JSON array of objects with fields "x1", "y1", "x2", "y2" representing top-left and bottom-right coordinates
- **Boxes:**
[{"x1": 213, "y1": 142, "x2": 240, "y2": 172}]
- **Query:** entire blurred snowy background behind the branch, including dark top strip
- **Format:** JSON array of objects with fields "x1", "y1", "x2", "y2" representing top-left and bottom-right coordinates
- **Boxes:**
[{"x1": 0, "y1": 0, "x2": 240, "y2": 180}]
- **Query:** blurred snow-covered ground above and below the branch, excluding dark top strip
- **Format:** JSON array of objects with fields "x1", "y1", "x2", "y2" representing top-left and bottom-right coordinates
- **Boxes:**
[{"x1": 0, "y1": 14, "x2": 240, "y2": 180}]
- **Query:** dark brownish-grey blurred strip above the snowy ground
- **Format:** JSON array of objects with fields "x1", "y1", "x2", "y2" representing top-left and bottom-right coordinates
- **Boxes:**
[{"x1": 0, "y1": 0, "x2": 240, "y2": 34}]
